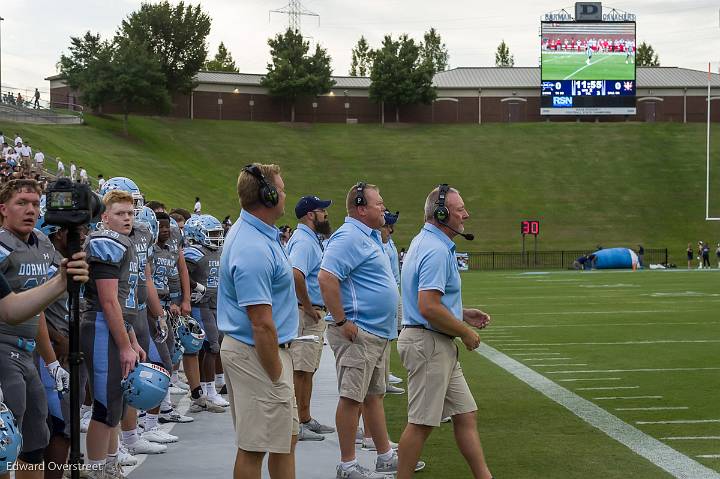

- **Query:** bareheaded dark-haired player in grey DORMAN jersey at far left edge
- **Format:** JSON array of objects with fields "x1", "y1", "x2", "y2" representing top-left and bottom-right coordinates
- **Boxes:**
[{"x1": 0, "y1": 180, "x2": 70, "y2": 478}]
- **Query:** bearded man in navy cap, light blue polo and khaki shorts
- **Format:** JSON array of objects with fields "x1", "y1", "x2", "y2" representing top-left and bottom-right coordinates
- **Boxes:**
[{"x1": 286, "y1": 196, "x2": 335, "y2": 441}]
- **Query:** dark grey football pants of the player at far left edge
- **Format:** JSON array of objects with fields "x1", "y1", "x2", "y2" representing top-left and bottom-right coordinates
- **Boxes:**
[{"x1": 0, "y1": 335, "x2": 50, "y2": 452}]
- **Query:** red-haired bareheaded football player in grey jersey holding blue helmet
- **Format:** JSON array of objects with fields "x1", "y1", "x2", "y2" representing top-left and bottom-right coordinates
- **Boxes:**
[{"x1": 80, "y1": 190, "x2": 145, "y2": 478}]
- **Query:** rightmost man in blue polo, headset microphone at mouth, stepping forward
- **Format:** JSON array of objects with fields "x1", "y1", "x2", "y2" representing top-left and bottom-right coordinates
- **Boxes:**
[{"x1": 397, "y1": 185, "x2": 492, "y2": 479}]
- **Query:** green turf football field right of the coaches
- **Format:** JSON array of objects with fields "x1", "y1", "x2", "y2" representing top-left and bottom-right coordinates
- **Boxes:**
[{"x1": 385, "y1": 270, "x2": 720, "y2": 479}]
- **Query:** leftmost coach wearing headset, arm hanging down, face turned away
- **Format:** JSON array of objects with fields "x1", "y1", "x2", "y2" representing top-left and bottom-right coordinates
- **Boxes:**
[{"x1": 217, "y1": 163, "x2": 299, "y2": 479}]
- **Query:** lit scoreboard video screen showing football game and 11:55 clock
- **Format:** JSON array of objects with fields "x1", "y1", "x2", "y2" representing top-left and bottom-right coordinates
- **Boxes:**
[{"x1": 540, "y1": 22, "x2": 637, "y2": 115}]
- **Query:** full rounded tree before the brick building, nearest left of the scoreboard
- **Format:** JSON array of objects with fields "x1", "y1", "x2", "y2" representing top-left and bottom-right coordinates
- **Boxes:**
[{"x1": 370, "y1": 34, "x2": 437, "y2": 123}]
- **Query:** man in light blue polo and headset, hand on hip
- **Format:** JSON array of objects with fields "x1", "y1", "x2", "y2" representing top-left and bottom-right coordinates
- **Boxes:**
[{"x1": 318, "y1": 183, "x2": 420, "y2": 479}]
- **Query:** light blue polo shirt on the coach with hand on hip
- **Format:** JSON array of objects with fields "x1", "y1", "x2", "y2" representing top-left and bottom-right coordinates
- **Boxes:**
[{"x1": 320, "y1": 217, "x2": 398, "y2": 339}]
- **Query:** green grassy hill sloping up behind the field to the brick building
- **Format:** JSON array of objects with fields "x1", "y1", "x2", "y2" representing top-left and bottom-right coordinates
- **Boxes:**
[{"x1": 0, "y1": 116, "x2": 720, "y2": 262}]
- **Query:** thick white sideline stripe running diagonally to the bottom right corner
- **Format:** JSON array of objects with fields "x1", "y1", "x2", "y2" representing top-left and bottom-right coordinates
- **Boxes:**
[{"x1": 475, "y1": 344, "x2": 720, "y2": 479}]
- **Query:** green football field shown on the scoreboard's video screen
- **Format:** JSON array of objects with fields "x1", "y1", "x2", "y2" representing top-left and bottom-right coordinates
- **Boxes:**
[{"x1": 542, "y1": 53, "x2": 635, "y2": 80}]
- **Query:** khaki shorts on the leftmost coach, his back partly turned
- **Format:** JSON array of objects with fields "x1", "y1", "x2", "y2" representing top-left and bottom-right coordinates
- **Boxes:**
[{"x1": 220, "y1": 336, "x2": 300, "y2": 454}]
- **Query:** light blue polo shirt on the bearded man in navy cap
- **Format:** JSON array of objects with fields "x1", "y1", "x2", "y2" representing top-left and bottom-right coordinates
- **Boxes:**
[{"x1": 285, "y1": 223, "x2": 325, "y2": 306}]
